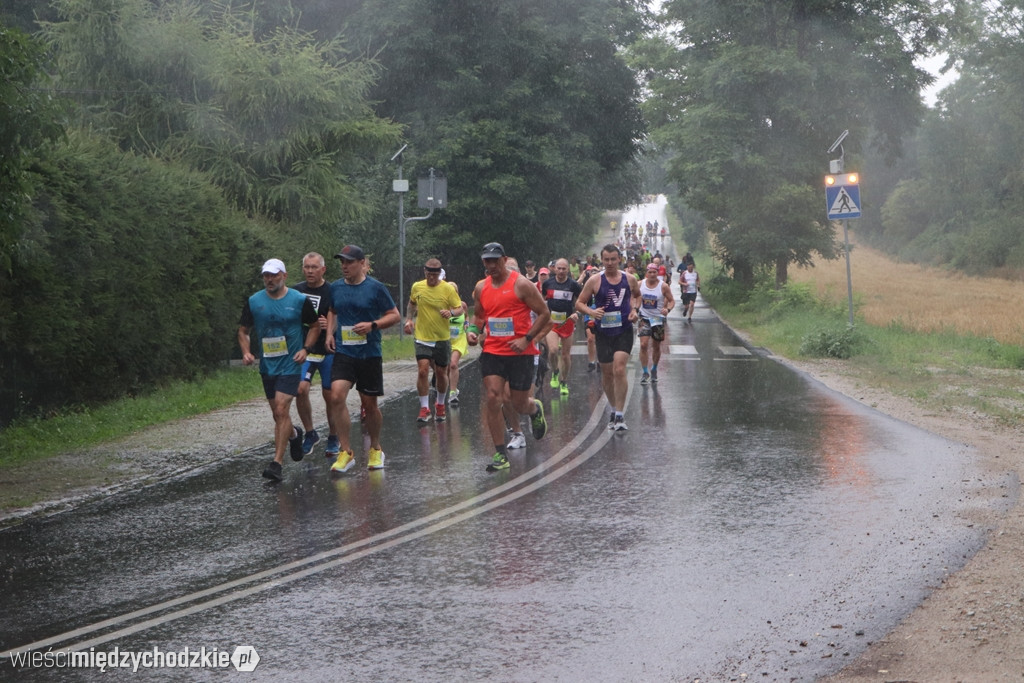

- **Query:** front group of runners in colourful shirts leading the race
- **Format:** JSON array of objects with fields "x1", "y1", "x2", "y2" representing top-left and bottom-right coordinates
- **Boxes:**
[{"x1": 238, "y1": 242, "x2": 699, "y2": 481}]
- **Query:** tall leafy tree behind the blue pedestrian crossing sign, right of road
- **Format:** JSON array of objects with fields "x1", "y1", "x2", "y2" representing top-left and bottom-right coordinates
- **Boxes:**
[{"x1": 636, "y1": 0, "x2": 942, "y2": 283}]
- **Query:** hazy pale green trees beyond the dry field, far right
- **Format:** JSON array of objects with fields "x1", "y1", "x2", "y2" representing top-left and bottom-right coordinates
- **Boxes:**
[{"x1": 883, "y1": 0, "x2": 1024, "y2": 276}]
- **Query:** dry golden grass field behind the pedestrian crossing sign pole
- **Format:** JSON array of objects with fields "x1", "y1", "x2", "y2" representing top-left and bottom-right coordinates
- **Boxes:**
[{"x1": 790, "y1": 233, "x2": 1024, "y2": 344}]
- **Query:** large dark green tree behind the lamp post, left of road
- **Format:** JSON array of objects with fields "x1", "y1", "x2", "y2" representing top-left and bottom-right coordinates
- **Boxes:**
[{"x1": 352, "y1": 0, "x2": 644, "y2": 260}]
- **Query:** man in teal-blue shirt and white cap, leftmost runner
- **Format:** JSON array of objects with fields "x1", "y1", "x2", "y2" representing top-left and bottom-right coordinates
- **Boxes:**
[{"x1": 239, "y1": 258, "x2": 319, "y2": 481}]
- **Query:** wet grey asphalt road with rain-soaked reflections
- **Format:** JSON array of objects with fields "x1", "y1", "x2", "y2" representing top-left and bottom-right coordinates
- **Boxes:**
[{"x1": 0, "y1": 301, "x2": 1012, "y2": 681}]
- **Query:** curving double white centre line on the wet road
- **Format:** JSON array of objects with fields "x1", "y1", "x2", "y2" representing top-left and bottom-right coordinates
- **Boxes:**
[{"x1": 0, "y1": 385, "x2": 633, "y2": 658}]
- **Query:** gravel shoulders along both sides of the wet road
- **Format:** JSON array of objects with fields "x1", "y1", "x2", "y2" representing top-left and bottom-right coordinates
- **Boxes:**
[{"x1": 0, "y1": 342, "x2": 1024, "y2": 683}]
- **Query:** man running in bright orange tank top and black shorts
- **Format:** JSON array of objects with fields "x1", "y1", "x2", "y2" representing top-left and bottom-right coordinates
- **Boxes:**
[{"x1": 467, "y1": 242, "x2": 551, "y2": 472}]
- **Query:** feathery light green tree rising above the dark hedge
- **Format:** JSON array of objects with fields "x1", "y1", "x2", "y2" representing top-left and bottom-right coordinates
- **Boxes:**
[{"x1": 43, "y1": 0, "x2": 401, "y2": 232}]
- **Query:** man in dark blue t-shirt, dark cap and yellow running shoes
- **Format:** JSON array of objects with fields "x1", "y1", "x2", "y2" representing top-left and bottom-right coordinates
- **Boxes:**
[{"x1": 327, "y1": 245, "x2": 401, "y2": 473}]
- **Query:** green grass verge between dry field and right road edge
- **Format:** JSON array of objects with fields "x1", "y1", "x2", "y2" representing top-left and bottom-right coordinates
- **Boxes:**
[{"x1": 696, "y1": 254, "x2": 1024, "y2": 425}]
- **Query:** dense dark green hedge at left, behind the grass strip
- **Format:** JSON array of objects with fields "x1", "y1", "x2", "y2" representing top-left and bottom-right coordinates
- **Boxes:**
[{"x1": 0, "y1": 134, "x2": 265, "y2": 426}]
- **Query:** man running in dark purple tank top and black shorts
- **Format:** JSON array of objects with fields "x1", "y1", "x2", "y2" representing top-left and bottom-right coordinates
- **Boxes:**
[{"x1": 577, "y1": 245, "x2": 640, "y2": 431}]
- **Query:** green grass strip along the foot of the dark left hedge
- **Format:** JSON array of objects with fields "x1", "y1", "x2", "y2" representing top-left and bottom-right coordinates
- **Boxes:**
[{"x1": 0, "y1": 334, "x2": 414, "y2": 468}]
